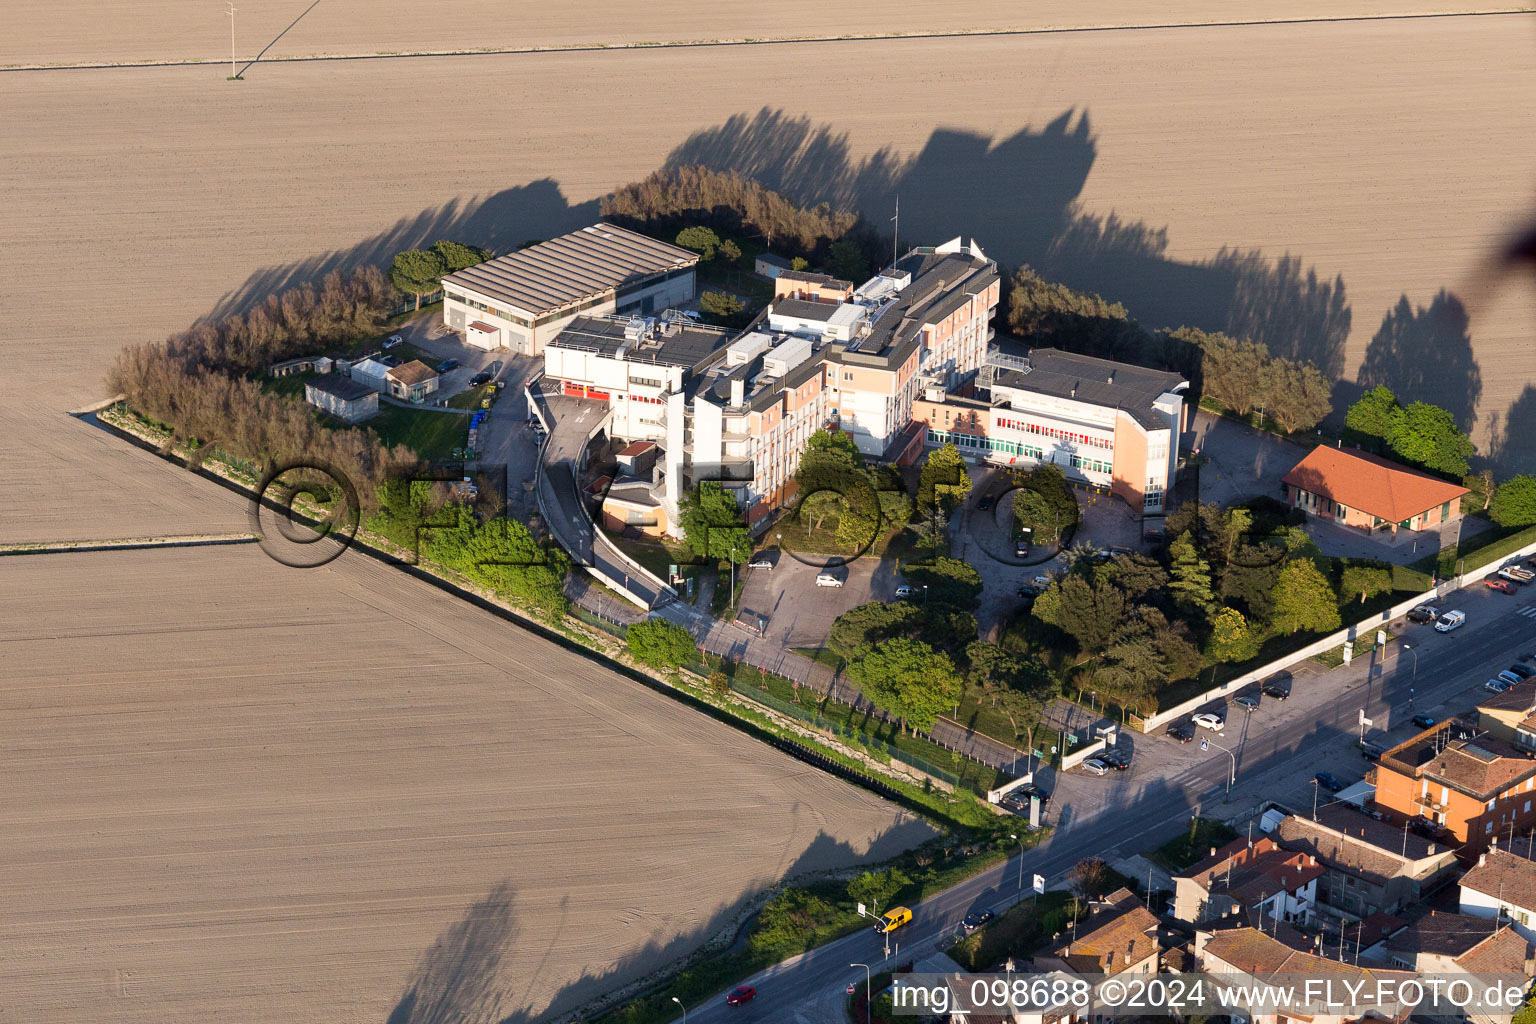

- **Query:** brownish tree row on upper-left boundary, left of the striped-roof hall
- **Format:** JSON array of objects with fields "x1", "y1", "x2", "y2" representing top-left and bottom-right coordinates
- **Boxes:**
[{"x1": 163, "y1": 267, "x2": 398, "y2": 373}]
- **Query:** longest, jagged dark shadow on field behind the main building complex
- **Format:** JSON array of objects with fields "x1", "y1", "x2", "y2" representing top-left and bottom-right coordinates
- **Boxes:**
[{"x1": 667, "y1": 107, "x2": 1350, "y2": 376}]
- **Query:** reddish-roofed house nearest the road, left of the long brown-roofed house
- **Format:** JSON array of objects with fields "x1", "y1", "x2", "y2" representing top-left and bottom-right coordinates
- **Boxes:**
[{"x1": 1174, "y1": 837, "x2": 1326, "y2": 926}]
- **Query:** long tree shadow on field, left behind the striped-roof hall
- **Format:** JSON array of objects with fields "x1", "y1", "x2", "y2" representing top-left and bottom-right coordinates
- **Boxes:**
[{"x1": 207, "y1": 178, "x2": 598, "y2": 319}]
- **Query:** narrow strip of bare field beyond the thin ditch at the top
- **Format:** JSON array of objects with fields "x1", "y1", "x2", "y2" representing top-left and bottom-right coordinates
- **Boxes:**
[{"x1": 0, "y1": 0, "x2": 1518, "y2": 68}]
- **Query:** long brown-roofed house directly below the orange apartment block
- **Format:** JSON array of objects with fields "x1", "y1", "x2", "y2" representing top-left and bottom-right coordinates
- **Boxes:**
[{"x1": 1273, "y1": 806, "x2": 1456, "y2": 921}]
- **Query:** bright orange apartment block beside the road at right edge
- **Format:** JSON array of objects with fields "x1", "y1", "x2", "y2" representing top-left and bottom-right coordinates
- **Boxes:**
[{"x1": 1376, "y1": 722, "x2": 1536, "y2": 858}]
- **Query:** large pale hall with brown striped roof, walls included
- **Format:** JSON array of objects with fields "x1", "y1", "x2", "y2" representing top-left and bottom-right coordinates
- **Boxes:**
[{"x1": 442, "y1": 224, "x2": 699, "y2": 356}]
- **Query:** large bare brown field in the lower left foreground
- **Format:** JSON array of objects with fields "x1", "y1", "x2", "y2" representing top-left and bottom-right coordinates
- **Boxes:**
[{"x1": 0, "y1": 547, "x2": 931, "y2": 1024}]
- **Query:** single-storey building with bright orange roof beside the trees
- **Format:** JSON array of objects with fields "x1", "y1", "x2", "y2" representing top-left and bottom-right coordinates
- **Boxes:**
[{"x1": 1281, "y1": 447, "x2": 1467, "y2": 537}]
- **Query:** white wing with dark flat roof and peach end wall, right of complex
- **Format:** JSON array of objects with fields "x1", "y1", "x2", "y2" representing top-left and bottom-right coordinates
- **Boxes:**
[{"x1": 912, "y1": 348, "x2": 1189, "y2": 513}]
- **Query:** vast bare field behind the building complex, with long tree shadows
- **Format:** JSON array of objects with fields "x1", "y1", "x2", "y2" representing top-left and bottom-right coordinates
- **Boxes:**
[{"x1": 0, "y1": 17, "x2": 1536, "y2": 552}]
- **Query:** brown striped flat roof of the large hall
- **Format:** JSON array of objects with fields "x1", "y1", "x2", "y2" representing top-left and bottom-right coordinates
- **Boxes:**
[{"x1": 442, "y1": 223, "x2": 699, "y2": 316}]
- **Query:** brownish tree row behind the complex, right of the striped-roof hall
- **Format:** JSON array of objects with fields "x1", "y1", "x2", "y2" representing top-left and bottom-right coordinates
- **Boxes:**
[{"x1": 599, "y1": 166, "x2": 880, "y2": 269}]
